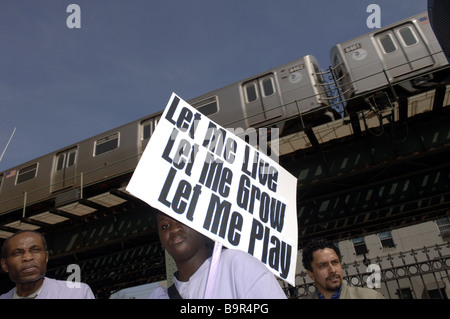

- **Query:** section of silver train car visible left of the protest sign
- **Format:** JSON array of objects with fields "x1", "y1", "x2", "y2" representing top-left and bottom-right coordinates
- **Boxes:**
[{"x1": 0, "y1": 114, "x2": 155, "y2": 215}]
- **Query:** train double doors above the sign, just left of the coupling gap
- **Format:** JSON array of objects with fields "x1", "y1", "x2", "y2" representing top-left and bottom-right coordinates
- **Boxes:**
[{"x1": 242, "y1": 73, "x2": 283, "y2": 126}]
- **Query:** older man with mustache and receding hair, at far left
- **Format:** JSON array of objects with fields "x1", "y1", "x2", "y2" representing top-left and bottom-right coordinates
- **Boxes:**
[{"x1": 0, "y1": 230, "x2": 94, "y2": 299}]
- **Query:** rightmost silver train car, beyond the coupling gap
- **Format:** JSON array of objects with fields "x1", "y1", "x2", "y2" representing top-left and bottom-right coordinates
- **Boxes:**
[{"x1": 330, "y1": 12, "x2": 448, "y2": 103}]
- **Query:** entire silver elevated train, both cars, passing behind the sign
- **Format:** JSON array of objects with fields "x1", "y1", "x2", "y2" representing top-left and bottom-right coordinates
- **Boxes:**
[{"x1": 0, "y1": 13, "x2": 448, "y2": 220}]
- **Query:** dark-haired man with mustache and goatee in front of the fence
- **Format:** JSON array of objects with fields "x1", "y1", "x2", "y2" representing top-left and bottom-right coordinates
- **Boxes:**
[{"x1": 302, "y1": 240, "x2": 384, "y2": 299}]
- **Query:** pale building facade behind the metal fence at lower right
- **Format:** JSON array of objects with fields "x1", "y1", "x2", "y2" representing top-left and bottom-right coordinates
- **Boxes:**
[{"x1": 286, "y1": 217, "x2": 450, "y2": 299}]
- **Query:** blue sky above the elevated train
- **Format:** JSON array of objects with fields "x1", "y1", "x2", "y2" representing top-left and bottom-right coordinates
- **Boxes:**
[{"x1": 0, "y1": 0, "x2": 427, "y2": 171}]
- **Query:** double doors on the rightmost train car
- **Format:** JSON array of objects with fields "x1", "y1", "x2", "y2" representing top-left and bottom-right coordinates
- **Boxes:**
[{"x1": 376, "y1": 23, "x2": 434, "y2": 78}]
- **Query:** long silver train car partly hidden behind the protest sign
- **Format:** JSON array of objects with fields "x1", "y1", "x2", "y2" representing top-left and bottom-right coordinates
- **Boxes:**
[{"x1": 0, "y1": 55, "x2": 333, "y2": 215}]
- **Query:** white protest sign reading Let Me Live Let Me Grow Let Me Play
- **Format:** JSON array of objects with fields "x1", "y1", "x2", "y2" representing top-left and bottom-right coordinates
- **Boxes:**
[{"x1": 127, "y1": 94, "x2": 297, "y2": 285}]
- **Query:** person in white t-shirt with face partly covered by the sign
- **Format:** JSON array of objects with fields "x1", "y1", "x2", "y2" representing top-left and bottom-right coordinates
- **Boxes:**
[{"x1": 149, "y1": 212, "x2": 286, "y2": 299}]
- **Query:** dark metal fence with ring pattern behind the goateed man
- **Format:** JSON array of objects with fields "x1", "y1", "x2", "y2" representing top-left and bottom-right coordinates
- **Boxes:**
[{"x1": 285, "y1": 242, "x2": 450, "y2": 299}]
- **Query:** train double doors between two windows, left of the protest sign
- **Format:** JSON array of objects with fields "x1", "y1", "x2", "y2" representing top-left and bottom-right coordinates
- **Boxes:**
[{"x1": 52, "y1": 147, "x2": 78, "y2": 192}]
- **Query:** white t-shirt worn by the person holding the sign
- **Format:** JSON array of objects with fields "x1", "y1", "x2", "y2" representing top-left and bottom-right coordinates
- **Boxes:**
[{"x1": 149, "y1": 249, "x2": 286, "y2": 299}]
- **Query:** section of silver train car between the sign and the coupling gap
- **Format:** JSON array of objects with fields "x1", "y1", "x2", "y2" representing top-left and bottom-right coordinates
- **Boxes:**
[{"x1": 189, "y1": 55, "x2": 335, "y2": 135}]
